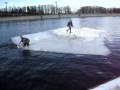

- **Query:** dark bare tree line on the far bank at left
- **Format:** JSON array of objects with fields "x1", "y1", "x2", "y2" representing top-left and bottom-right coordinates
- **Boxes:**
[{"x1": 0, "y1": 5, "x2": 72, "y2": 17}]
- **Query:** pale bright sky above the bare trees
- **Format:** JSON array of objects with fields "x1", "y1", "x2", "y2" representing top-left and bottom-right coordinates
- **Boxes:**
[{"x1": 0, "y1": 0, "x2": 120, "y2": 11}]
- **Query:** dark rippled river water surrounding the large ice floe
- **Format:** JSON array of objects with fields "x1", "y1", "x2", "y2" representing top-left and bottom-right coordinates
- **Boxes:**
[{"x1": 0, "y1": 17, "x2": 120, "y2": 90}]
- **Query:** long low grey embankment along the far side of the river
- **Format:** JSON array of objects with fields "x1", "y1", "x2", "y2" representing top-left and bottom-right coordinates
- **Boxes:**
[{"x1": 0, "y1": 14, "x2": 120, "y2": 22}]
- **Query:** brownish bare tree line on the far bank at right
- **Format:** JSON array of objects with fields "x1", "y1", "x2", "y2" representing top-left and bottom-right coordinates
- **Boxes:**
[{"x1": 77, "y1": 6, "x2": 120, "y2": 14}]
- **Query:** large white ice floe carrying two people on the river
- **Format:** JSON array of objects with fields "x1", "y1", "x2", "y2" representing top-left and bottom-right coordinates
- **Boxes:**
[{"x1": 12, "y1": 27, "x2": 110, "y2": 55}]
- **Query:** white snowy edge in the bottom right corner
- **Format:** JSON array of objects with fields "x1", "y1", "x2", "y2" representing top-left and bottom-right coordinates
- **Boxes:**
[{"x1": 89, "y1": 77, "x2": 120, "y2": 90}]
